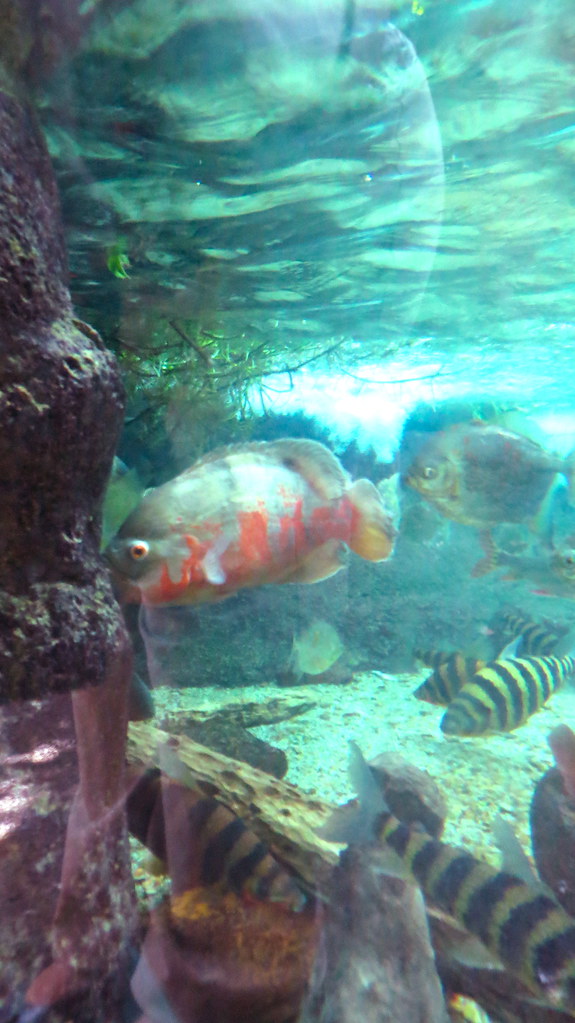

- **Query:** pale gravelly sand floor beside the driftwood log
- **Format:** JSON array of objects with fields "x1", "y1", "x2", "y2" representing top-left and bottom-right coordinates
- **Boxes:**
[{"x1": 150, "y1": 670, "x2": 575, "y2": 863}]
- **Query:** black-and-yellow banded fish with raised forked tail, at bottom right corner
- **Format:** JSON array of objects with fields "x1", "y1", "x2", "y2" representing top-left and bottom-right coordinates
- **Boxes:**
[{"x1": 320, "y1": 743, "x2": 575, "y2": 1011}]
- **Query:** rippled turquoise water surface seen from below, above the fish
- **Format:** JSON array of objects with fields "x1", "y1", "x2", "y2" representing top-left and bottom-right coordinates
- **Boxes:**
[{"x1": 44, "y1": 0, "x2": 573, "y2": 452}]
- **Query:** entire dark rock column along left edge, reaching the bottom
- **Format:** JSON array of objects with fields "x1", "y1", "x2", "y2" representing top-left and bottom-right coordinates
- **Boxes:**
[{"x1": 0, "y1": 28, "x2": 137, "y2": 1023}]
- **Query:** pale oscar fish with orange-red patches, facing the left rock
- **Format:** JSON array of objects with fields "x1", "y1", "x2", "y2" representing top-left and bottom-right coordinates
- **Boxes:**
[{"x1": 106, "y1": 440, "x2": 396, "y2": 605}]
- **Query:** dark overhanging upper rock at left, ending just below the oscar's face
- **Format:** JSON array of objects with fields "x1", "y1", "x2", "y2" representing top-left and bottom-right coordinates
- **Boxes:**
[{"x1": 0, "y1": 72, "x2": 123, "y2": 703}]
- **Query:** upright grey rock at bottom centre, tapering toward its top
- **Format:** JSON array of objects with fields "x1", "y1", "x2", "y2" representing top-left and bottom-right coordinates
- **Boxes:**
[{"x1": 299, "y1": 848, "x2": 448, "y2": 1023}]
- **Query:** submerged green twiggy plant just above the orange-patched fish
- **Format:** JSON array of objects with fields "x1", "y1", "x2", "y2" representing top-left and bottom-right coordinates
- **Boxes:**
[{"x1": 112, "y1": 313, "x2": 391, "y2": 466}]
